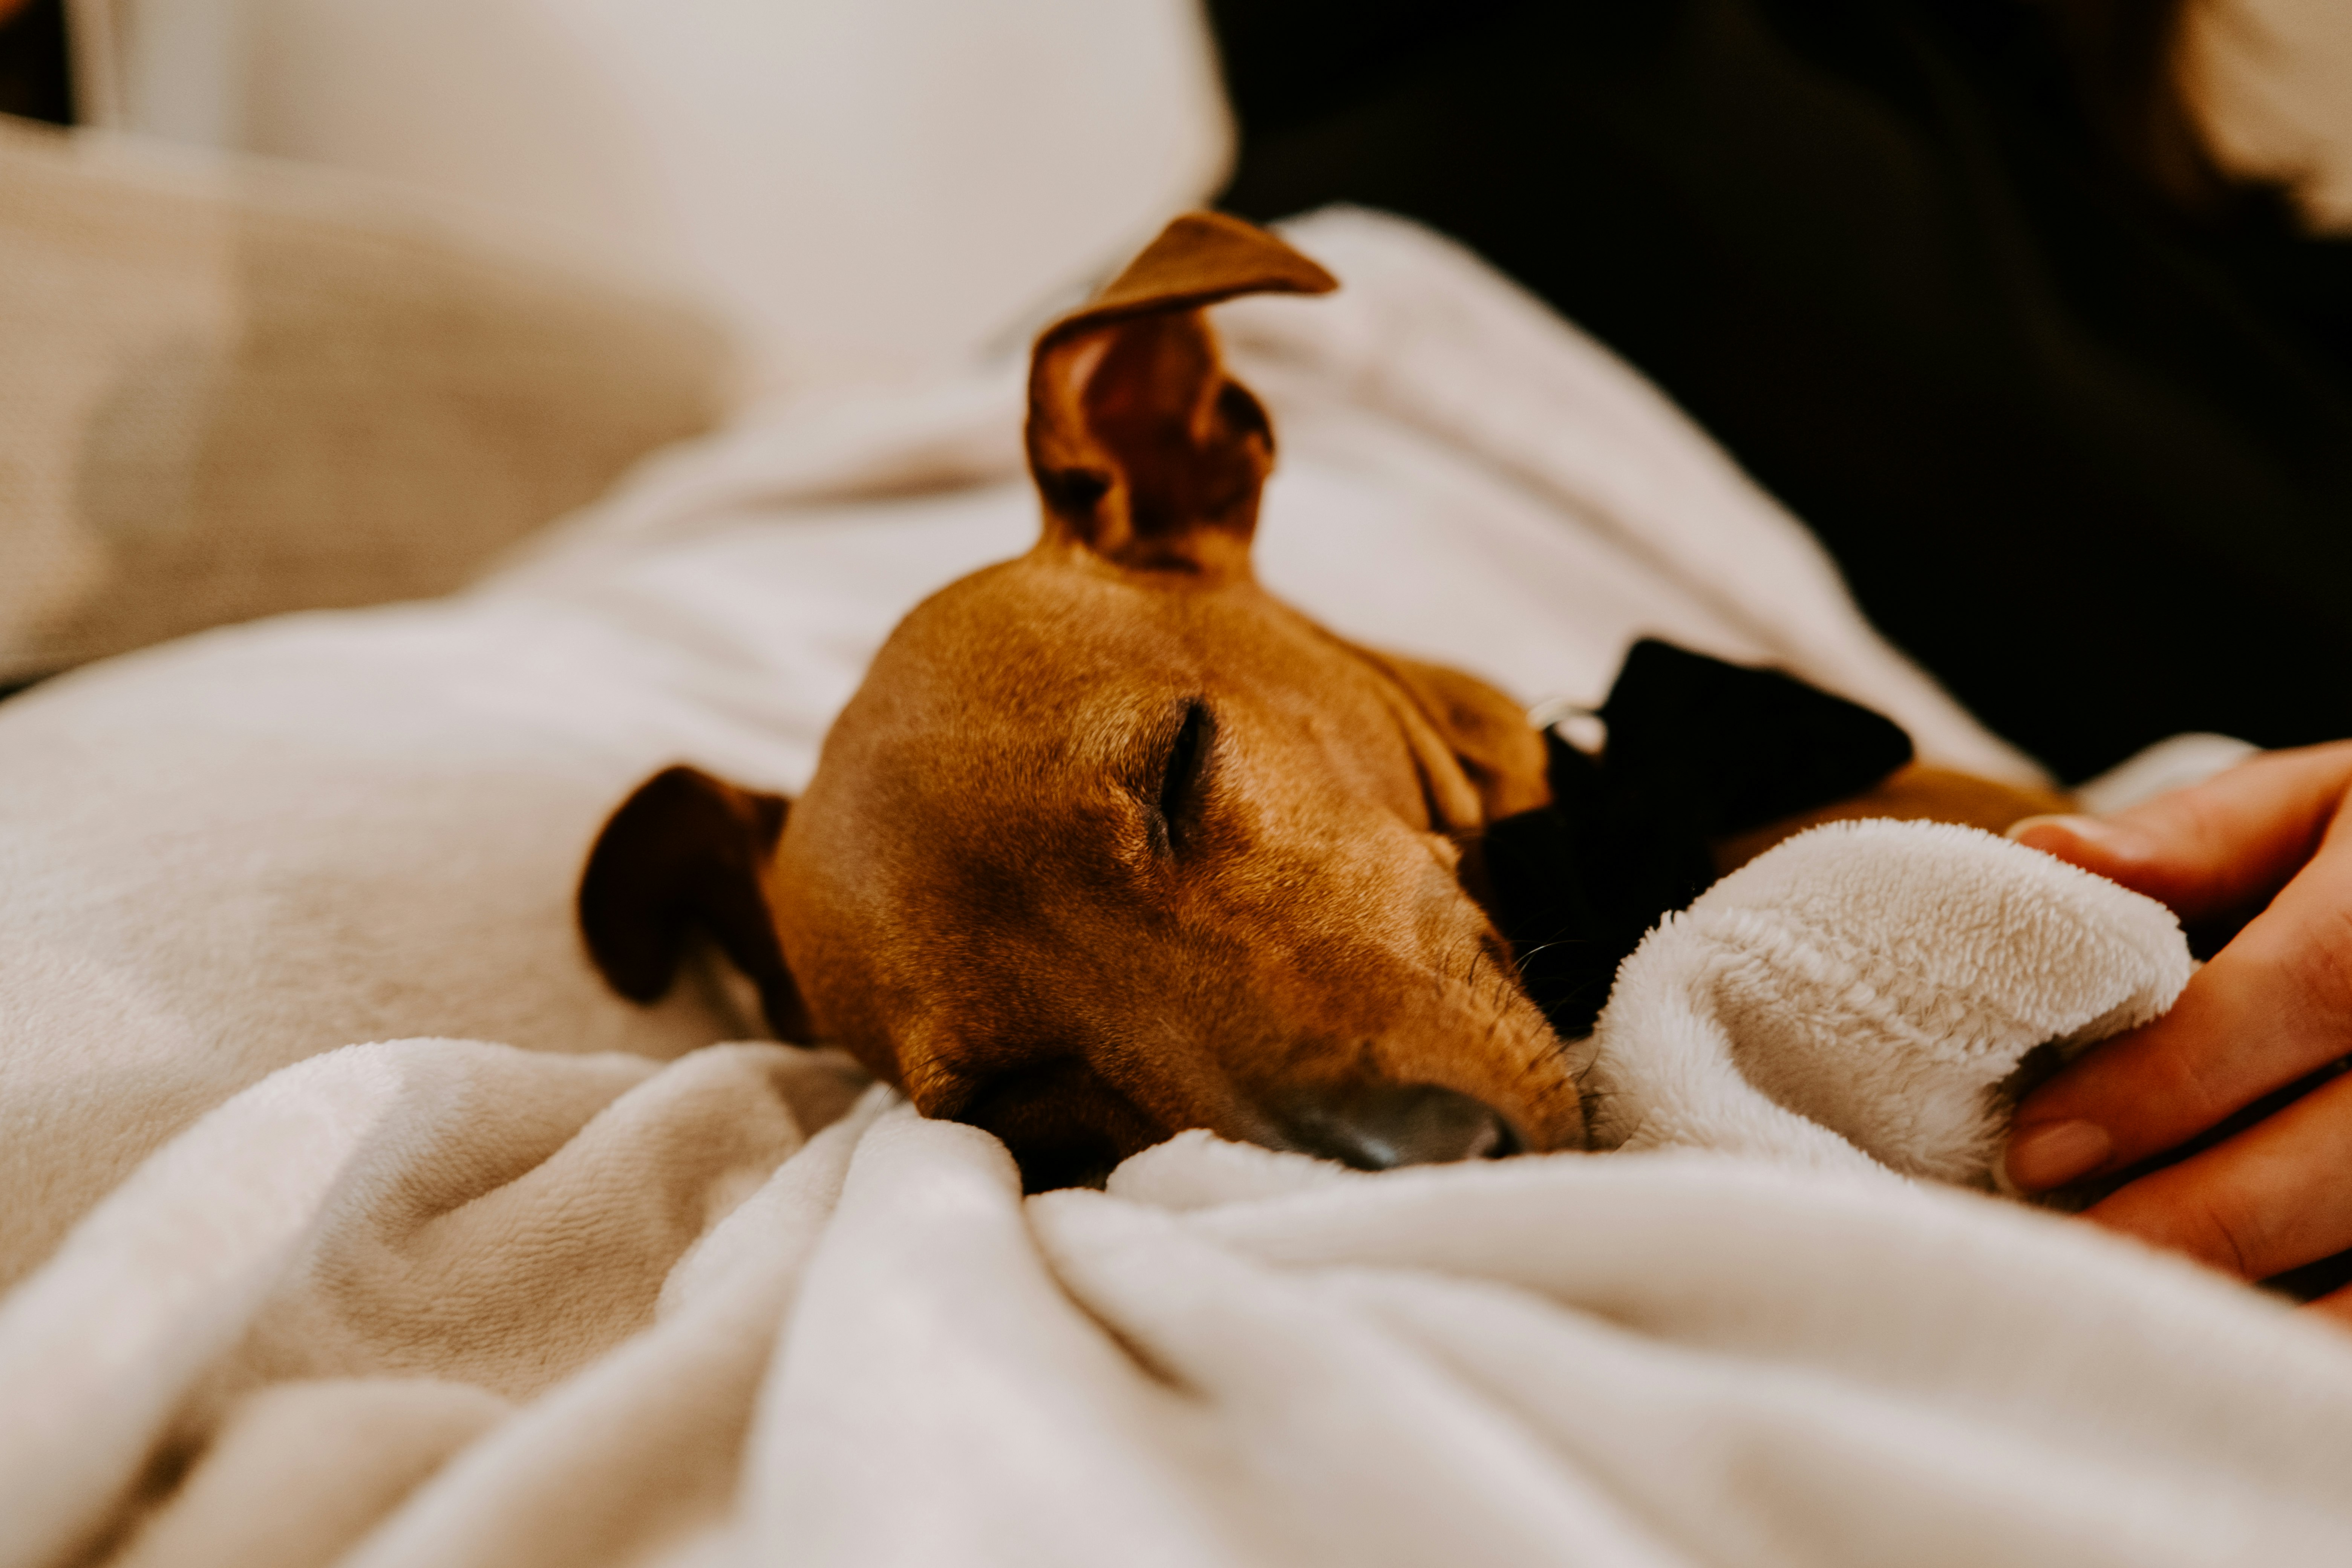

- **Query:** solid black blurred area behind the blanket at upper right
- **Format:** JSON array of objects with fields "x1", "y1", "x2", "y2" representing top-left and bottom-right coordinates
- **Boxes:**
[{"x1": 1211, "y1": 0, "x2": 2352, "y2": 778}]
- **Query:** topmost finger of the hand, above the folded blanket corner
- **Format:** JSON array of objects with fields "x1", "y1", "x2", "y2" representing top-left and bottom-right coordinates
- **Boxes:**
[{"x1": 2009, "y1": 741, "x2": 2352, "y2": 922}]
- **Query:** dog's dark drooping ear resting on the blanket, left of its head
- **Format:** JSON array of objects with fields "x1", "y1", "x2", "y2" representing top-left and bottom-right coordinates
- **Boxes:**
[{"x1": 579, "y1": 766, "x2": 809, "y2": 1041}]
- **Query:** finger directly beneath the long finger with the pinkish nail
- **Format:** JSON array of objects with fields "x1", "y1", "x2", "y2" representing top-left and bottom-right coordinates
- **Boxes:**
[{"x1": 2084, "y1": 1076, "x2": 2352, "y2": 1279}]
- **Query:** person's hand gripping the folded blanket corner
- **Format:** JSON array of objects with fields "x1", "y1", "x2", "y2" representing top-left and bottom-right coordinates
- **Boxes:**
[{"x1": 2006, "y1": 743, "x2": 2352, "y2": 1321}]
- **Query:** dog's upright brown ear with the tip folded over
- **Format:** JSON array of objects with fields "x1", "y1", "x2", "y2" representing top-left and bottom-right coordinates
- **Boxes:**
[{"x1": 1028, "y1": 211, "x2": 1338, "y2": 578}]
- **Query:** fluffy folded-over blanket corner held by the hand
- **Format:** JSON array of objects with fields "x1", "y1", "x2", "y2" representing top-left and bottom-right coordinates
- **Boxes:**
[{"x1": 1588, "y1": 821, "x2": 2197, "y2": 1187}]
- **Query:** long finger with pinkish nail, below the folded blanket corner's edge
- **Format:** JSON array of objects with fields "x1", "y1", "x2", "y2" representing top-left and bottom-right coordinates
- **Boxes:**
[{"x1": 2004, "y1": 813, "x2": 2352, "y2": 1192}]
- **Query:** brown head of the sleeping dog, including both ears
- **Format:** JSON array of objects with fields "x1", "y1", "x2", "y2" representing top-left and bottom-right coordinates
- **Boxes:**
[{"x1": 581, "y1": 216, "x2": 1583, "y2": 1190}]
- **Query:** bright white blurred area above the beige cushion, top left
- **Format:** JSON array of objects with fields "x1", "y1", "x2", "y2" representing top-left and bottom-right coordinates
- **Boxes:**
[{"x1": 73, "y1": 0, "x2": 1233, "y2": 388}]
